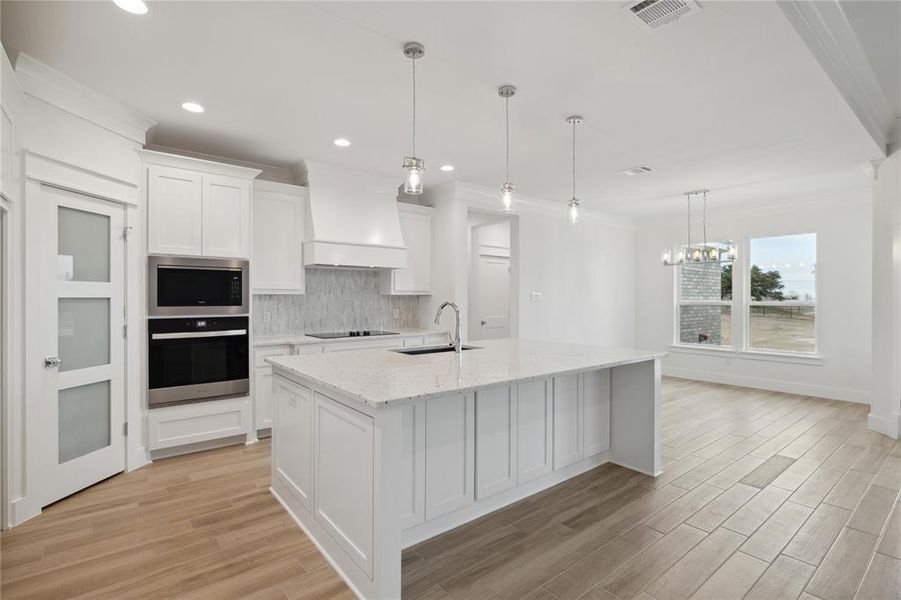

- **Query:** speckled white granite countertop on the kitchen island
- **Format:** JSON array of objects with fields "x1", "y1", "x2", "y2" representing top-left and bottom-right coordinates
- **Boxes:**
[{"x1": 266, "y1": 338, "x2": 665, "y2": 406}]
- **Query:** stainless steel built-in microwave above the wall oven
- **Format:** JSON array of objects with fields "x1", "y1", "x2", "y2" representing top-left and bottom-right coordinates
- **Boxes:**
[{"x1": 147, "y1": 256, "x2": 250, "y2": 316}]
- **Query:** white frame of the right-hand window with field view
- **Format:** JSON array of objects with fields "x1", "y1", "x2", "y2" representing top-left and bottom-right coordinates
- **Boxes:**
[{"x1": 732, "y1": 231, "x2": 821, "y2": 356}]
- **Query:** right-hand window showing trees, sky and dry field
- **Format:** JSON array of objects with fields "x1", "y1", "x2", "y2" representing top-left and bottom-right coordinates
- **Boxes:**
[{"x1": 745, "y1": 233, "x2": 817, "y2": 353}]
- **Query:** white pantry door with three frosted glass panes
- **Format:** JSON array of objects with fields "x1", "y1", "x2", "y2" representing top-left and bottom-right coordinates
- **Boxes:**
[{"x1": 39, "y1": 186, "x2": 125, "y2": 505}]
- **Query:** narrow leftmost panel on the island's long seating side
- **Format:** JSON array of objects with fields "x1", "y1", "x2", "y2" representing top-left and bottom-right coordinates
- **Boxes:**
[{"x1": 400, "y1": 400, "x2": 425, "y2": 529}]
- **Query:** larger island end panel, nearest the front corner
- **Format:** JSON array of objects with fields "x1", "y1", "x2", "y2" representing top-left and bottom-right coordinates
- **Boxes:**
[{"x1": 313, "y1": 393, "x2": 375, "y2": 578}]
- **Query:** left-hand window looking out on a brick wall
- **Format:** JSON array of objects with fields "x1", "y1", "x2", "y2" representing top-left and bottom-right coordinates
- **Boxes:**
[{"x1": 676, "y1": 263, "x2": 732, "y2": 347}]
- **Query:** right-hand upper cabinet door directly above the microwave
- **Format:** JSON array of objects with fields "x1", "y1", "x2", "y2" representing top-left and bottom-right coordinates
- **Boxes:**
[{"x1": 202, "y1": 175, "x2": 250, "y2": 258}]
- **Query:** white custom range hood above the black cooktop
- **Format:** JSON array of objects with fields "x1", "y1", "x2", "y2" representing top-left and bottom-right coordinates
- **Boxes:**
[{"x1": 303, "y1": 161, "x2": 407, "y2": 269}]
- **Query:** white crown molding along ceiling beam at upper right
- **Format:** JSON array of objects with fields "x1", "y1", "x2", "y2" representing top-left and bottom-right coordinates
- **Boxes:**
[{"x1": 777, "y1": 0, "x2": 897, "y2": 156}]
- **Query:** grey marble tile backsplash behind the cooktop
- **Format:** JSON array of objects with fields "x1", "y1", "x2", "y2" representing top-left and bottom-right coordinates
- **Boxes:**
[{"x1": 253, "y1": 269, "x2": 420, "y2": 337}]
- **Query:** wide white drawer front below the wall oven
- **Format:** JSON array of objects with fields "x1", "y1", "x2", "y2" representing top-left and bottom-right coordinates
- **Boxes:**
[{"x1": 148, "y1": 397, "x2": 252, "y2": 450}]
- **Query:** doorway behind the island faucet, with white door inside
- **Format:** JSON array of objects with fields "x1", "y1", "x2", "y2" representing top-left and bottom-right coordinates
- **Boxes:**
[{"x1": 467, "y1": 211, "x2": 514, "y2": 340}]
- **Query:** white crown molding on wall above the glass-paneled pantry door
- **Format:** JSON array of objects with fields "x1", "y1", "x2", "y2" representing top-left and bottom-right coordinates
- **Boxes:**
[{"x1": 15, "y1": 52, "x2": 156, "y2": 145}]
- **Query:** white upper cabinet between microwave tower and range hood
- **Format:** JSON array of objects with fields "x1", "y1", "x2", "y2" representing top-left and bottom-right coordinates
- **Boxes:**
[{"x1": 250, "y1": 181, "x2": 307, "y2": 294}]
